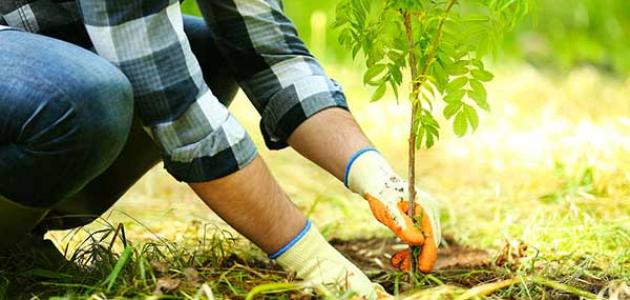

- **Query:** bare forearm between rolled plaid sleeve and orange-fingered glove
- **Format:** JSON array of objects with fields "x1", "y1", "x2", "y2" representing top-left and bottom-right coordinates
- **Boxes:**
[{"x1": 288, "y1": 108, "x2": 371, "y2": 181}]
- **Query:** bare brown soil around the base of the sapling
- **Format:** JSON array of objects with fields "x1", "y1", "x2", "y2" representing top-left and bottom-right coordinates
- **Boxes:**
[{"x1": 331, "y1": 236, "x2": 612, "y2": 299}]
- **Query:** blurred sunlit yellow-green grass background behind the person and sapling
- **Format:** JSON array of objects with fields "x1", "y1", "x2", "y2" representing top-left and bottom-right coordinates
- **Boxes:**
[{"x1": 53, "y1": 0, "x2": 630, "y2": 278}]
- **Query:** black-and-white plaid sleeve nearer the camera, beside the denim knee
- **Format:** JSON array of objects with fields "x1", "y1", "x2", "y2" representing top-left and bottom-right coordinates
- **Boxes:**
[{"x1": 79, "y1": 0, "x2": 256, "y2": 182}]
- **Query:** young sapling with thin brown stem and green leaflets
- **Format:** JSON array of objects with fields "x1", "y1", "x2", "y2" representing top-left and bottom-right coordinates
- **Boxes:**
[{"x1": 335, "y1": 0, "x2": 532, "y2": 278}]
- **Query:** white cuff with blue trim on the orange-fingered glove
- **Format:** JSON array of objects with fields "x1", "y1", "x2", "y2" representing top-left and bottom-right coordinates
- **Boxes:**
[{"x1": 344, "y1": 148, "x2": 398, "y2": 197}]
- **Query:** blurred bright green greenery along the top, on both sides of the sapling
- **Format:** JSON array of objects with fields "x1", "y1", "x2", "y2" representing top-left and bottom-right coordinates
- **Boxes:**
[{"x1": 184, "y1": 0, "x2": 630, "y2": 75}]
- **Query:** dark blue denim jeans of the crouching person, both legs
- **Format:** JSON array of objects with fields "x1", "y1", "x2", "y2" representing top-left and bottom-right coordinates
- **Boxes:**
[{"x1": 0, "y1": 16, "x2": 238, "y2": 230}]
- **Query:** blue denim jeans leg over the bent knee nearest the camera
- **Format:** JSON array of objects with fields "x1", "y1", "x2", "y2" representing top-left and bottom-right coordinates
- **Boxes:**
[{"x1": 0, "y1": 31, "x2": 133, "y2": 207}]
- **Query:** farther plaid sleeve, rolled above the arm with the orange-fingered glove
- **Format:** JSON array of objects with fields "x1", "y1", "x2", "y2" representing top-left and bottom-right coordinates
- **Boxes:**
[{"x1": 197, "y1": 0, "x2": 348, "y2": 149}]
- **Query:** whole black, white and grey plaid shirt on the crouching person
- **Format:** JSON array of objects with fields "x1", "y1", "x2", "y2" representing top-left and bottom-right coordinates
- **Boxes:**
[{"x1": 0, "y1": 0, "x2": 347, "y2": 182}]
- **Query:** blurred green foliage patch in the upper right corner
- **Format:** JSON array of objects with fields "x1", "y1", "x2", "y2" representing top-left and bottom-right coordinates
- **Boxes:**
[{"x1": 505, "y1": 0, "x2": 630, "y2": 74}]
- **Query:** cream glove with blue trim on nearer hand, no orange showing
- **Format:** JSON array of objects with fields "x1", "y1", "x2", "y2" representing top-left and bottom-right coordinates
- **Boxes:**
[{"x1": 269, "y1": 221, "x2": 384, "y2": 299}]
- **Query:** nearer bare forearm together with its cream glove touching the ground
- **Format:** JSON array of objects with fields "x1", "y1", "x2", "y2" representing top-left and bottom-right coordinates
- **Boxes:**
[{"x1": 190, "y1": 157, "x2": 375, "y2": 299}]
